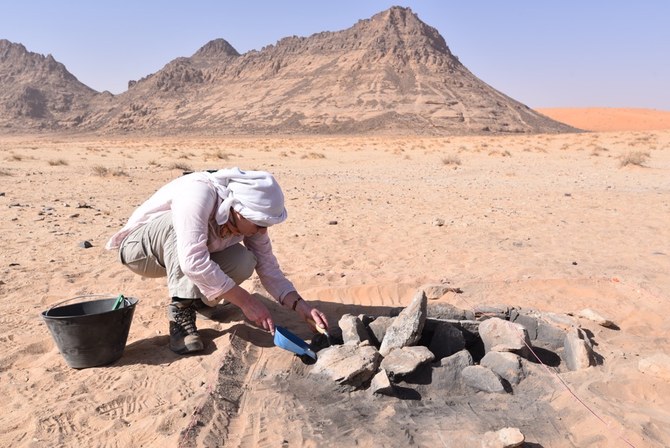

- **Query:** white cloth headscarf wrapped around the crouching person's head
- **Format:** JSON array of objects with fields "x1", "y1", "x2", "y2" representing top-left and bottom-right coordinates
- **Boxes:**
[{"x1": 206, "y1": 168, "x2": 287, "y2": 227}]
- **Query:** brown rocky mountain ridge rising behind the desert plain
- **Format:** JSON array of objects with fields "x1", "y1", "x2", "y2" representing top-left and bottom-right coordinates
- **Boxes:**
[{"x1": 0, "y1": 7, "x2": 574, "y2": 135}]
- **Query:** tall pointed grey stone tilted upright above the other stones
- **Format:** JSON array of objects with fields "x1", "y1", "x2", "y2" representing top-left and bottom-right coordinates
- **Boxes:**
[{"x1": 379, "y1": 290, "x2": 428, "y2": 356}]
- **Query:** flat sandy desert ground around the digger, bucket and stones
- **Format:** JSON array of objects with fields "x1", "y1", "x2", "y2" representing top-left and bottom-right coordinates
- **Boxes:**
[{"x1": 0, "y1": 111, "x2": 670, "y2": 447}]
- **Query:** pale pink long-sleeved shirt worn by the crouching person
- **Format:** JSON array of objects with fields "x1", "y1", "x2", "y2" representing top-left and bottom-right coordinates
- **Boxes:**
[{"x1": 106, "y1": 173, "x2": 295, "y2": 304}]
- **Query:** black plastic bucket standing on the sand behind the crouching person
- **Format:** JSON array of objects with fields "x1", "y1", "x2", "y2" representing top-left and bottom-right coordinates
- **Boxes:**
[{"x1": 42, "y1": 297, "x2": 138, "y2": 369}]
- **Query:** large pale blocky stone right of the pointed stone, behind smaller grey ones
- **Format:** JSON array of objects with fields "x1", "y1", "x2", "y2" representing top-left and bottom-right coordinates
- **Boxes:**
[{"x1": 479, "y1": 317, "x2": 530, "y2": 358}]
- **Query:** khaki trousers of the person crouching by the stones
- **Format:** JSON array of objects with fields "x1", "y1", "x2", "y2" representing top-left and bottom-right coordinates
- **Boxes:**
[{"x1": 119, "y1": 212, "x2": 256, "y2": 304}]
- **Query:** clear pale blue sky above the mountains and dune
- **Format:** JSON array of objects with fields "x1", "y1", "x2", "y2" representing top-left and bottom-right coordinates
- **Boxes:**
[{"x1": 0, "y1": 0, "x2": 670, "y2": 110}]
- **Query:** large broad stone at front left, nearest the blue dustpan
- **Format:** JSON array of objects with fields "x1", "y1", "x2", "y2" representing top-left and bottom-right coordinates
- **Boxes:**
[{"x1": 310, "y1": 342, "x2": 381, "y2": 388}]
